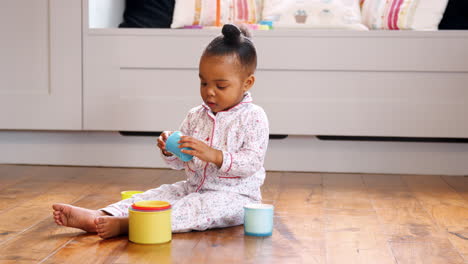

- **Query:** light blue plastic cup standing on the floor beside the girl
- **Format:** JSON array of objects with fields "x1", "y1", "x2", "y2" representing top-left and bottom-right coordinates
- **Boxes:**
[{"x1": 244, "y1": 204, "x2": 274, "y2": 237}]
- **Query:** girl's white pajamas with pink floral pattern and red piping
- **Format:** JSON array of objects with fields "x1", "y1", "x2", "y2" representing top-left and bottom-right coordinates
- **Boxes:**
[{"x1": 101, "y1": 93, "x2": 269, "y2": 232}]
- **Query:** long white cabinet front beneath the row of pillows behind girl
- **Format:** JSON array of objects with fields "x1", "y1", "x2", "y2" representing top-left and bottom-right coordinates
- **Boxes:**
[{"x1": 83, "y1": 0, "x2": 468, "y2": 138}]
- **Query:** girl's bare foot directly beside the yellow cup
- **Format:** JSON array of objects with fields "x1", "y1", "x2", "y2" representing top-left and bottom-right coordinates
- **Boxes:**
[{"x1": 94, "y1": 216, "x2": 128, "y2": 238}]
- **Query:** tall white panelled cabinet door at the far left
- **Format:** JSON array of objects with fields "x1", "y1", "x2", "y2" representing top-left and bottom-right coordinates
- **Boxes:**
[{"x1": 0, "y1": 0, "x2": 82, "y2": 130}]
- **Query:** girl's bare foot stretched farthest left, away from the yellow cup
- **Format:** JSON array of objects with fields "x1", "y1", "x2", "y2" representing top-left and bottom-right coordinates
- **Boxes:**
[{"x1": 52, "y1": 204, "x2": 105, "y2": 233}]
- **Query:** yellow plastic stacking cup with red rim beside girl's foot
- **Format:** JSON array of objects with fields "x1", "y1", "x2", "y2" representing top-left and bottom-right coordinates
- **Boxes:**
[{"x1": 128, "y1": 201, "x2": 172, "y2": 244}]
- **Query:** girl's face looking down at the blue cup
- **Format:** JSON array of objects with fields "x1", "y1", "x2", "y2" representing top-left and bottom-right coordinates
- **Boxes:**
[{"x1": 199, "y1": 55, "x2": 255, "y2": 114}]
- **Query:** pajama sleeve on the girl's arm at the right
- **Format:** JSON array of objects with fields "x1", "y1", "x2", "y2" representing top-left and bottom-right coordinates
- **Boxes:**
[{"x1": 219, "y1": 109, "x2": 269, "y2": 178}]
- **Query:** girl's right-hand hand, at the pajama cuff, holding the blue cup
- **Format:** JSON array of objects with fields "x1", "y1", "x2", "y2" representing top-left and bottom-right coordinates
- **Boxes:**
[{"x1": 179, "y1": 136, "x2": 223, "y2": 168}]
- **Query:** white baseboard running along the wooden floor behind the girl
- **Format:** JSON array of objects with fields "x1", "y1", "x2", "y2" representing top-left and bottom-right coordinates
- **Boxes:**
[{"x1": 0, "y1": 131, "x2": 468, "y2": 175}]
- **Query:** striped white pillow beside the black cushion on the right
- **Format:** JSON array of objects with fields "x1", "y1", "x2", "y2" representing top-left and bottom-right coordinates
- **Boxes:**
[{"x1": 362, "y1": 0, "x2": 447, "y2": 30}]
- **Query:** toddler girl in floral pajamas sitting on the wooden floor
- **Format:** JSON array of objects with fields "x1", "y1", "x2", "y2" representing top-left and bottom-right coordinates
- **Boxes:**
[{"x1": 53, "y1": 24, "x2": 269, "y2": 238}]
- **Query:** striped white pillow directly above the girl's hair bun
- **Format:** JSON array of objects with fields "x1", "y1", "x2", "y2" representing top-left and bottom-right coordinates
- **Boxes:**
[{"x1": 171, "y1": 0, "x2": 258, "y2": 28}]
